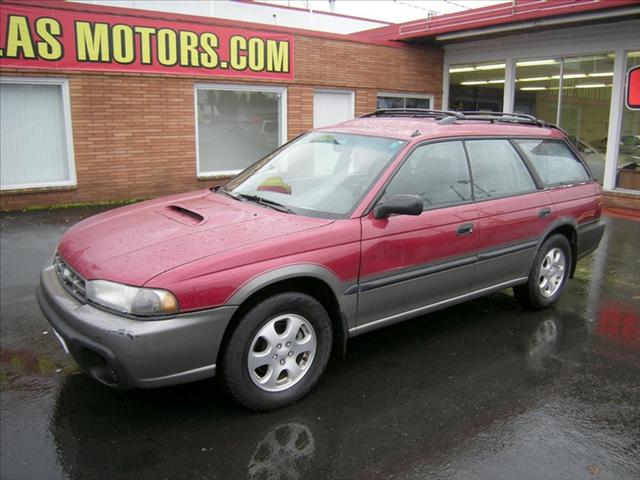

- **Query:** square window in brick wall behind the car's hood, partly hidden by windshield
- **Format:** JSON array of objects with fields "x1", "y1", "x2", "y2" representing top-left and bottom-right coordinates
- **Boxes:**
[{"x1": 196, "y1": 85, "x2": 286, "y2": 176}]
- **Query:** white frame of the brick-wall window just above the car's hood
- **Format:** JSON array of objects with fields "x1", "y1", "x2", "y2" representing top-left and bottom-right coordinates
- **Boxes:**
[{"x1": 193, "y1": 83, "x2": 287, "y2": 180}]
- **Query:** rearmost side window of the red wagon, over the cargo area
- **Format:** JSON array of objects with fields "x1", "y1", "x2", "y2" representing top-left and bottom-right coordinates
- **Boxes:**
[{"x1": 515, "y1": 140, "x2": 589, "y2": 185}]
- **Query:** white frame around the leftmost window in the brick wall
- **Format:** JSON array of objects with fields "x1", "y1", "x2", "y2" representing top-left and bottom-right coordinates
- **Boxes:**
[{"x1": 0, "y1": 76, "x2": 78, "y2": 192}]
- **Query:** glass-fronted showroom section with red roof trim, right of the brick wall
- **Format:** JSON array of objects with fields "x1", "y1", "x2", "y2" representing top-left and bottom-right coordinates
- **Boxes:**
[{"x1": 370, "y1": 0, "x2": 640, "y2": 209}]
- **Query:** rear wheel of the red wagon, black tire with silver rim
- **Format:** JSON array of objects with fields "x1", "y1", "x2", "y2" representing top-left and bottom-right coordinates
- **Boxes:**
[{"x1": 513, "y1": 234, "x2": 573, "y2": 310}]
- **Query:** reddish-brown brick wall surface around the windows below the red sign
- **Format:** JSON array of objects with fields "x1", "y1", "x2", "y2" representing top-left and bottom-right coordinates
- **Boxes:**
[{"x1": 0, "y1": 36, "x2": 443, "y2": 210}]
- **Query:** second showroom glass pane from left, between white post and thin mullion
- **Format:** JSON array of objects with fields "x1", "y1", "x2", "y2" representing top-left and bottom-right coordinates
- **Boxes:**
[{"x1": 513, "y1": 58, "x2": 560, "y2": 123}]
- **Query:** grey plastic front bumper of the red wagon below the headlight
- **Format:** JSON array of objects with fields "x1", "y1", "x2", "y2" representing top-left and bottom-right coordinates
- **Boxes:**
[{"x1": 36, "y1": 266, "x2": 237, "y2": 388}]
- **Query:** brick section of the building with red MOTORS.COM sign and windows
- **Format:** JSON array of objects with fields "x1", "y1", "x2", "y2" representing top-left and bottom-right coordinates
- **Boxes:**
[{"x1": 0, "y1": 2, "x2": 443, "y2": 209}]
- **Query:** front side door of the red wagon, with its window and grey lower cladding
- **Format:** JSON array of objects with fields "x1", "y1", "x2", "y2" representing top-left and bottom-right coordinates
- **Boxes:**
[{"x1": 358, "y1": 141, "x2": 477, "y2": 326}]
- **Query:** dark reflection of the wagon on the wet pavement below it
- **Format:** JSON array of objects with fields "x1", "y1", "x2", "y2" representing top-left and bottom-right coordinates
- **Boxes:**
[{"x1": 47, "y1": 308, "x2": 604, "y2": 480}]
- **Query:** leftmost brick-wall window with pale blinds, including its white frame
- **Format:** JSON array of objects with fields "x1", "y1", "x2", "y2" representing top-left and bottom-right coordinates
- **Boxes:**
[{"x1": 0, "y1": 77, "x2": 75, "y2": 190}]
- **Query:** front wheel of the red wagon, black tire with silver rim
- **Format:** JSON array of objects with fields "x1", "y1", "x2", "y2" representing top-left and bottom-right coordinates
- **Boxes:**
[{"x1": 221, "y1": 292, "x2": 333, "y2": 411}]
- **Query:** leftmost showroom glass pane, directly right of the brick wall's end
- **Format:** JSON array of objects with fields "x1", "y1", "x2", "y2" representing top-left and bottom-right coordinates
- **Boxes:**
[{"x1": 449, "y1": 61, "x2": 505, "y2": 112}]
